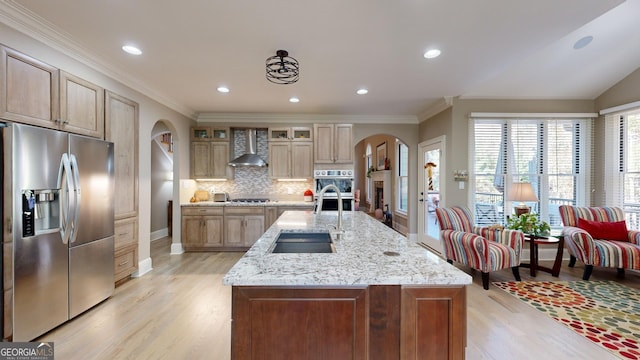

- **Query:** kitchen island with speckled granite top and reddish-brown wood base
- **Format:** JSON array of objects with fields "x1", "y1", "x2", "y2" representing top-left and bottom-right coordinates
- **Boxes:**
[{"x1": 224, "y1": 211, "x2": 471, "y2": 359}]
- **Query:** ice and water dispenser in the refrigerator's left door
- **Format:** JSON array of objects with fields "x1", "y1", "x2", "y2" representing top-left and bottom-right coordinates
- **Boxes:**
[{"x1": 22, "y1": 189, "x2": 60, "y2": 237}]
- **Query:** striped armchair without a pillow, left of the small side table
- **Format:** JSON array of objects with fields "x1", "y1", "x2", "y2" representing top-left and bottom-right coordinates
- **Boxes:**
[{"x1": 436, "y1": 206, "x2": 524, "y2": 290}]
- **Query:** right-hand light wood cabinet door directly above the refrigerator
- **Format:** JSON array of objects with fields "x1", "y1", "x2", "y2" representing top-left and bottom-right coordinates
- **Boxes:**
[{"x1": 60, "y1": 71, "x2": 104, "y2": 139}]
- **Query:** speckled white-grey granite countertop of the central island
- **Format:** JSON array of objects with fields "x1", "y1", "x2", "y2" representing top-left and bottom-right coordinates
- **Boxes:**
[{"x1": 223, "y1": 211, "x2": 471, "y2": 286}]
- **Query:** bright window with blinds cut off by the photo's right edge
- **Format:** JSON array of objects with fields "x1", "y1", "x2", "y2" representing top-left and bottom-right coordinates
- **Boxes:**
[{"x1": 605, "y1": 109, "x2": 640, "y2": 230}]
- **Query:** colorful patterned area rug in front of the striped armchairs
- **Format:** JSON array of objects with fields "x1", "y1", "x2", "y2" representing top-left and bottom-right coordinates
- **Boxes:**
[{"x1": 493, "y1": 281, "x2": 640, "y2": 359}]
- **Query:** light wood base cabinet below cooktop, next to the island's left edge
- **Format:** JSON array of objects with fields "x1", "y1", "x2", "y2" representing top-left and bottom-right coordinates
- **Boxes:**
[{"x1": 224, "y1": 206, "x2": 265, "y2": 249}]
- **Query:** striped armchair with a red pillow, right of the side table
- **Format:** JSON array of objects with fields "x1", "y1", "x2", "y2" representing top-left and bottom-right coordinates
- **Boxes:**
[{"x1": 560, "y1": 205, "x2": 640, "y2": 280}]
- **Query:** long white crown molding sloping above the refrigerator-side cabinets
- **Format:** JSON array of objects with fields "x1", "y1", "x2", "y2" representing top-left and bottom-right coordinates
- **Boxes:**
[{"x1": 0, "y1": 0, "x2": 196, "y2": 120}]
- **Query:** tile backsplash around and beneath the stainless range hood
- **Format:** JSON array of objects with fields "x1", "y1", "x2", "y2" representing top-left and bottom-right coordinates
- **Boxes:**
[{"x1": 196, "y1": 129, "x2": 313, "y2": 201}]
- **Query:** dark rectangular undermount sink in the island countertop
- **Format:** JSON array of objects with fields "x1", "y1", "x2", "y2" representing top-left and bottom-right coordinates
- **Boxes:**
[{"x1": 271, "y1": 231, "x2": 334, "y2": 254}]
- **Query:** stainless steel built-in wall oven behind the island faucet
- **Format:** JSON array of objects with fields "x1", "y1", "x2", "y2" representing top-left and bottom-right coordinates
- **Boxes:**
[{"x1": 313, "y1": 170, "x2": 354, "y2": 211}]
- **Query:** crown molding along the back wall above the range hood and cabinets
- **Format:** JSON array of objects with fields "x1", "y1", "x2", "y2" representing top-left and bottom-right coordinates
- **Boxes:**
[{"x1": 197, "y1": 113, "x2": 418, "y2": 124}]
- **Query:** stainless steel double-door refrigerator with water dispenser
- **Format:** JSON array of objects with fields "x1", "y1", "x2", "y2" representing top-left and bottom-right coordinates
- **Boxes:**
[{"x1": 2, "y1": 124, "x2": 114, "y2": 341}]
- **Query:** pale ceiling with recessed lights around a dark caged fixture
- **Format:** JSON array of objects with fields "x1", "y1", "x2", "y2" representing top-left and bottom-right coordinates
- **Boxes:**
[{"x1": 0, "y1": 0, "x2": 640, "y2": 119}]
